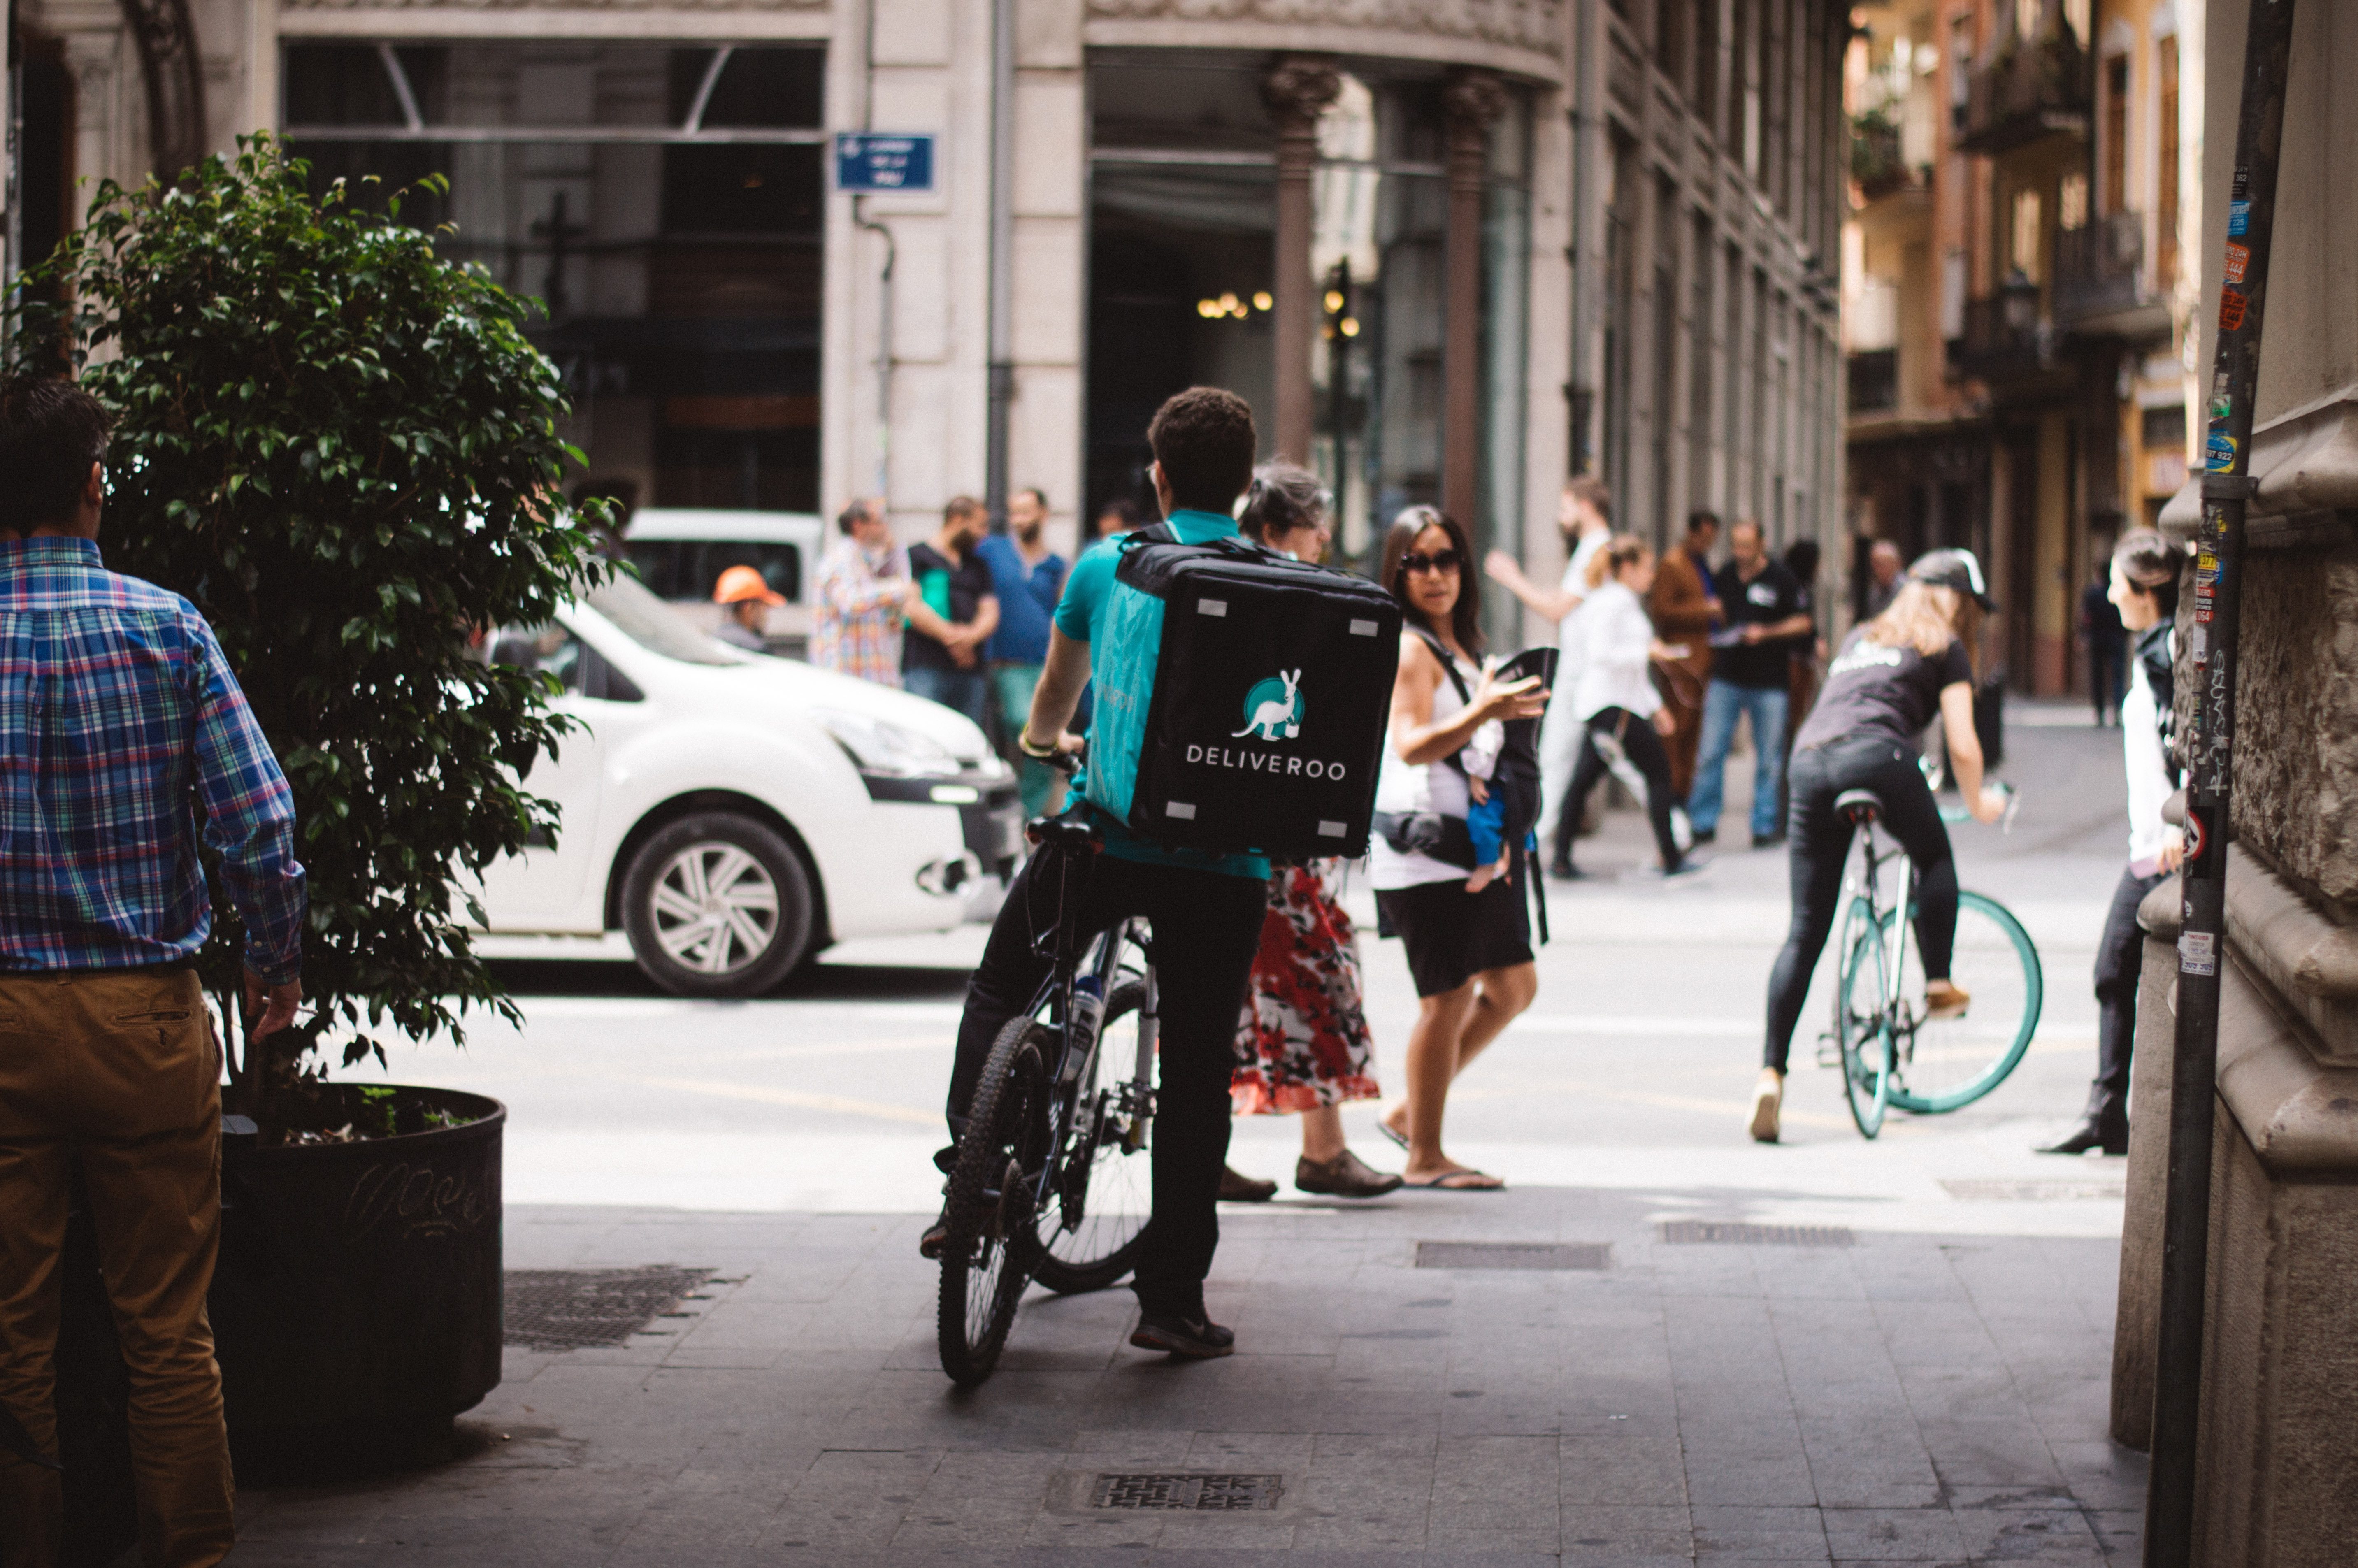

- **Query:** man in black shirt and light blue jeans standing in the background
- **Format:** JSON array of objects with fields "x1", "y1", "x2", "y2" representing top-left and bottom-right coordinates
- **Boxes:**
[{"x1": 1686, "y1": 516, "x2": 1809, "y2": 849}]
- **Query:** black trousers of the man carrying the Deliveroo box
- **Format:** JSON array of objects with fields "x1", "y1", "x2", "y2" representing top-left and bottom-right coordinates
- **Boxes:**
[{"x1": 950, "y1": 856, "x2": 1268, "y2": 1318}]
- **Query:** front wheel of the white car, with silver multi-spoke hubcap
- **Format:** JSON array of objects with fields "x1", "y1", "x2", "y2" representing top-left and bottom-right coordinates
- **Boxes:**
[{"x1": 623, "y1": 811, "x2": 811, "y2": 997}]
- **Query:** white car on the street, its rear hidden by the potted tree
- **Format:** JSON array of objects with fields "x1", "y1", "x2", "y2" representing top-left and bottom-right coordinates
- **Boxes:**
[{"x1": 483, "y1": 575, "x2": 1023, "y2": 997}]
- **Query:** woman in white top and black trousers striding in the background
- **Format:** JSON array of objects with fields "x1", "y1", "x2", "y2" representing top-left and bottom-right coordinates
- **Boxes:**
[{"x1": 1566, "y1": 533, "x2": 1703, "y2": 877}]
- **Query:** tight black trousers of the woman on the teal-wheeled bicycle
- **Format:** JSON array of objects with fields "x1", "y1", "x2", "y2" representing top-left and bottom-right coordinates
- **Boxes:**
[{"x1": 1761, "y1": 738, "x2": 1957, "y2": 1073}]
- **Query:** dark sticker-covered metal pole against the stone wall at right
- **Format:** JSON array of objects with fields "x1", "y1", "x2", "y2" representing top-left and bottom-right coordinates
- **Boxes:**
[{"x1": 2146, "y1": 0, "x2": 2294, "y2": 1568}]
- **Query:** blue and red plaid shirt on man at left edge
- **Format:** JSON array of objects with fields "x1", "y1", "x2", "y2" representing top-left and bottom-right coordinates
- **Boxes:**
[{"x1": 0, "y1": 538, "x2": 304, "y2": 983}]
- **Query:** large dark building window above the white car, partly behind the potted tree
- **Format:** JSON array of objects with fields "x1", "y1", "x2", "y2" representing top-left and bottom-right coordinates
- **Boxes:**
[{"x1": 283, "y1": 42, "x2": 825, "y2": 512}]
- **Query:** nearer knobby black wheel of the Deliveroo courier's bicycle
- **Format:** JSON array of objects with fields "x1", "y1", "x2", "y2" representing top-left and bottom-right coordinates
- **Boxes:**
[{"x1": 939, "y1": 1019, "x2": 1047, "y2": 1389}]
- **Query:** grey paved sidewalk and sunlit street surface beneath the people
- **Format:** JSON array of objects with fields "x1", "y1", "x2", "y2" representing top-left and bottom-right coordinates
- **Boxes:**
[{"x1": 231, "y1": 707, "x2": 2143, "y2": 1568}]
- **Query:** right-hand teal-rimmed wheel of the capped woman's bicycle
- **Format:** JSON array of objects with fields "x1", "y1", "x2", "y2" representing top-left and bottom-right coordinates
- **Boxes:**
[{"x1": 1891, "y1": 894, "x2": 2044, "y2": 1113}]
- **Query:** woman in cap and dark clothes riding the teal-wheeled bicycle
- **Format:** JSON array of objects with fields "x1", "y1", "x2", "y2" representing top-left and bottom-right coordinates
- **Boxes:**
[{"x1": 1752, "y1": 549, "x2": 2007, "y2": 1143}]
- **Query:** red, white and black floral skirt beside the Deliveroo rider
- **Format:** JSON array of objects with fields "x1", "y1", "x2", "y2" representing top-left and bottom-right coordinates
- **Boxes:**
[{"x1": 1229, "y1": 861, "x2": 1382, "y2": 1115}]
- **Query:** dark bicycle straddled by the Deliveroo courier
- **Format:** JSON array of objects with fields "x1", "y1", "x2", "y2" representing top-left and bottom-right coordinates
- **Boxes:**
[{"x1": 939, "y1": 818, "x2": 1158, "y2": 1389}]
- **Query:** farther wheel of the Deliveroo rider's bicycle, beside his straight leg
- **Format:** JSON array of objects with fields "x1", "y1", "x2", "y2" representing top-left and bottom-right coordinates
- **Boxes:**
[{"x1": 1033, "y1": 981, "x2": 1155, "y2": 1292}]
